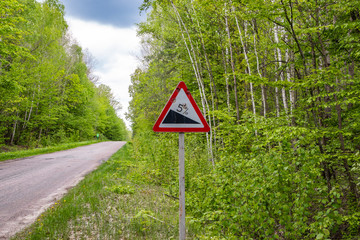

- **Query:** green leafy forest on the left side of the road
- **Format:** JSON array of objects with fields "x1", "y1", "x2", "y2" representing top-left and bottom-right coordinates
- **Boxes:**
[{"x1": 0, "y1": 0, "x2": 128, "y2": 147}]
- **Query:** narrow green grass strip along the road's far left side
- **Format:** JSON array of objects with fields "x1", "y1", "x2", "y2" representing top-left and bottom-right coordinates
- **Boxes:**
[{"x1": 0, "y1": 141, "x2": 98, "y2": 161}]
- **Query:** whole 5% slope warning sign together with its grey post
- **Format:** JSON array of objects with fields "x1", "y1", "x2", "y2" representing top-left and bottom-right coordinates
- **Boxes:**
[{"x1": 153, "y1": 82, "x2": 210, "y2": 240}]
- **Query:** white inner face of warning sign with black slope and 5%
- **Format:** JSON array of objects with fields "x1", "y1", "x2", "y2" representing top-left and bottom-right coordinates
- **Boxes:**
[{"x1": 159, "y1": 88, "x2": 204, "y2": 128}]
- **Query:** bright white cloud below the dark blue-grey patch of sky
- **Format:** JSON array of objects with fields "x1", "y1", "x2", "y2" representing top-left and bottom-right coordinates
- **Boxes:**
[{"x1": 66, "y1": 17, "x2": 140, "y2": 126}]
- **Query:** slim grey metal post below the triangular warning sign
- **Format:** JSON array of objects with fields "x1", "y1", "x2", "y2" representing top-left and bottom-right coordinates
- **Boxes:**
[{"x1": 179, "y1": 133, "x2": 186, "y2": 240}]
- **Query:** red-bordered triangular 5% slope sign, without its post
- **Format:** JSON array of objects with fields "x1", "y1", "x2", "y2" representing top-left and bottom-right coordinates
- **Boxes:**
[{"x1": 153, "y1": 82, "x2": 210, "y2": 132}]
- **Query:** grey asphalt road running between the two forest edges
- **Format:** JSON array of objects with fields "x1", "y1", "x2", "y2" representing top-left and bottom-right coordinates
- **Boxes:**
[{"x1": 0, "y1": 142, "x2": 125, "y2": 239}]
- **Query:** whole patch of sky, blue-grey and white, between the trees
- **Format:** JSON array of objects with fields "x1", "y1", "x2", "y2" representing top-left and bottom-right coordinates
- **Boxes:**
[{"x1": 60, "y1": 0, "x2": 145, "y2": 128}]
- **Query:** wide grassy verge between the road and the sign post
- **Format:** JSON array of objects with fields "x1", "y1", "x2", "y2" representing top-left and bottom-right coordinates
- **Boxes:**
[{"x1": 12, "y1": 143, "x2": 194, "y2": 240}]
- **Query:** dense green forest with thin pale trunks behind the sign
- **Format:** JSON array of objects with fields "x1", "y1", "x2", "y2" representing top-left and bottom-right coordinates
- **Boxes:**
[{"x1": 129, "y1": 0, "x2": 360, "y2": 239}]
